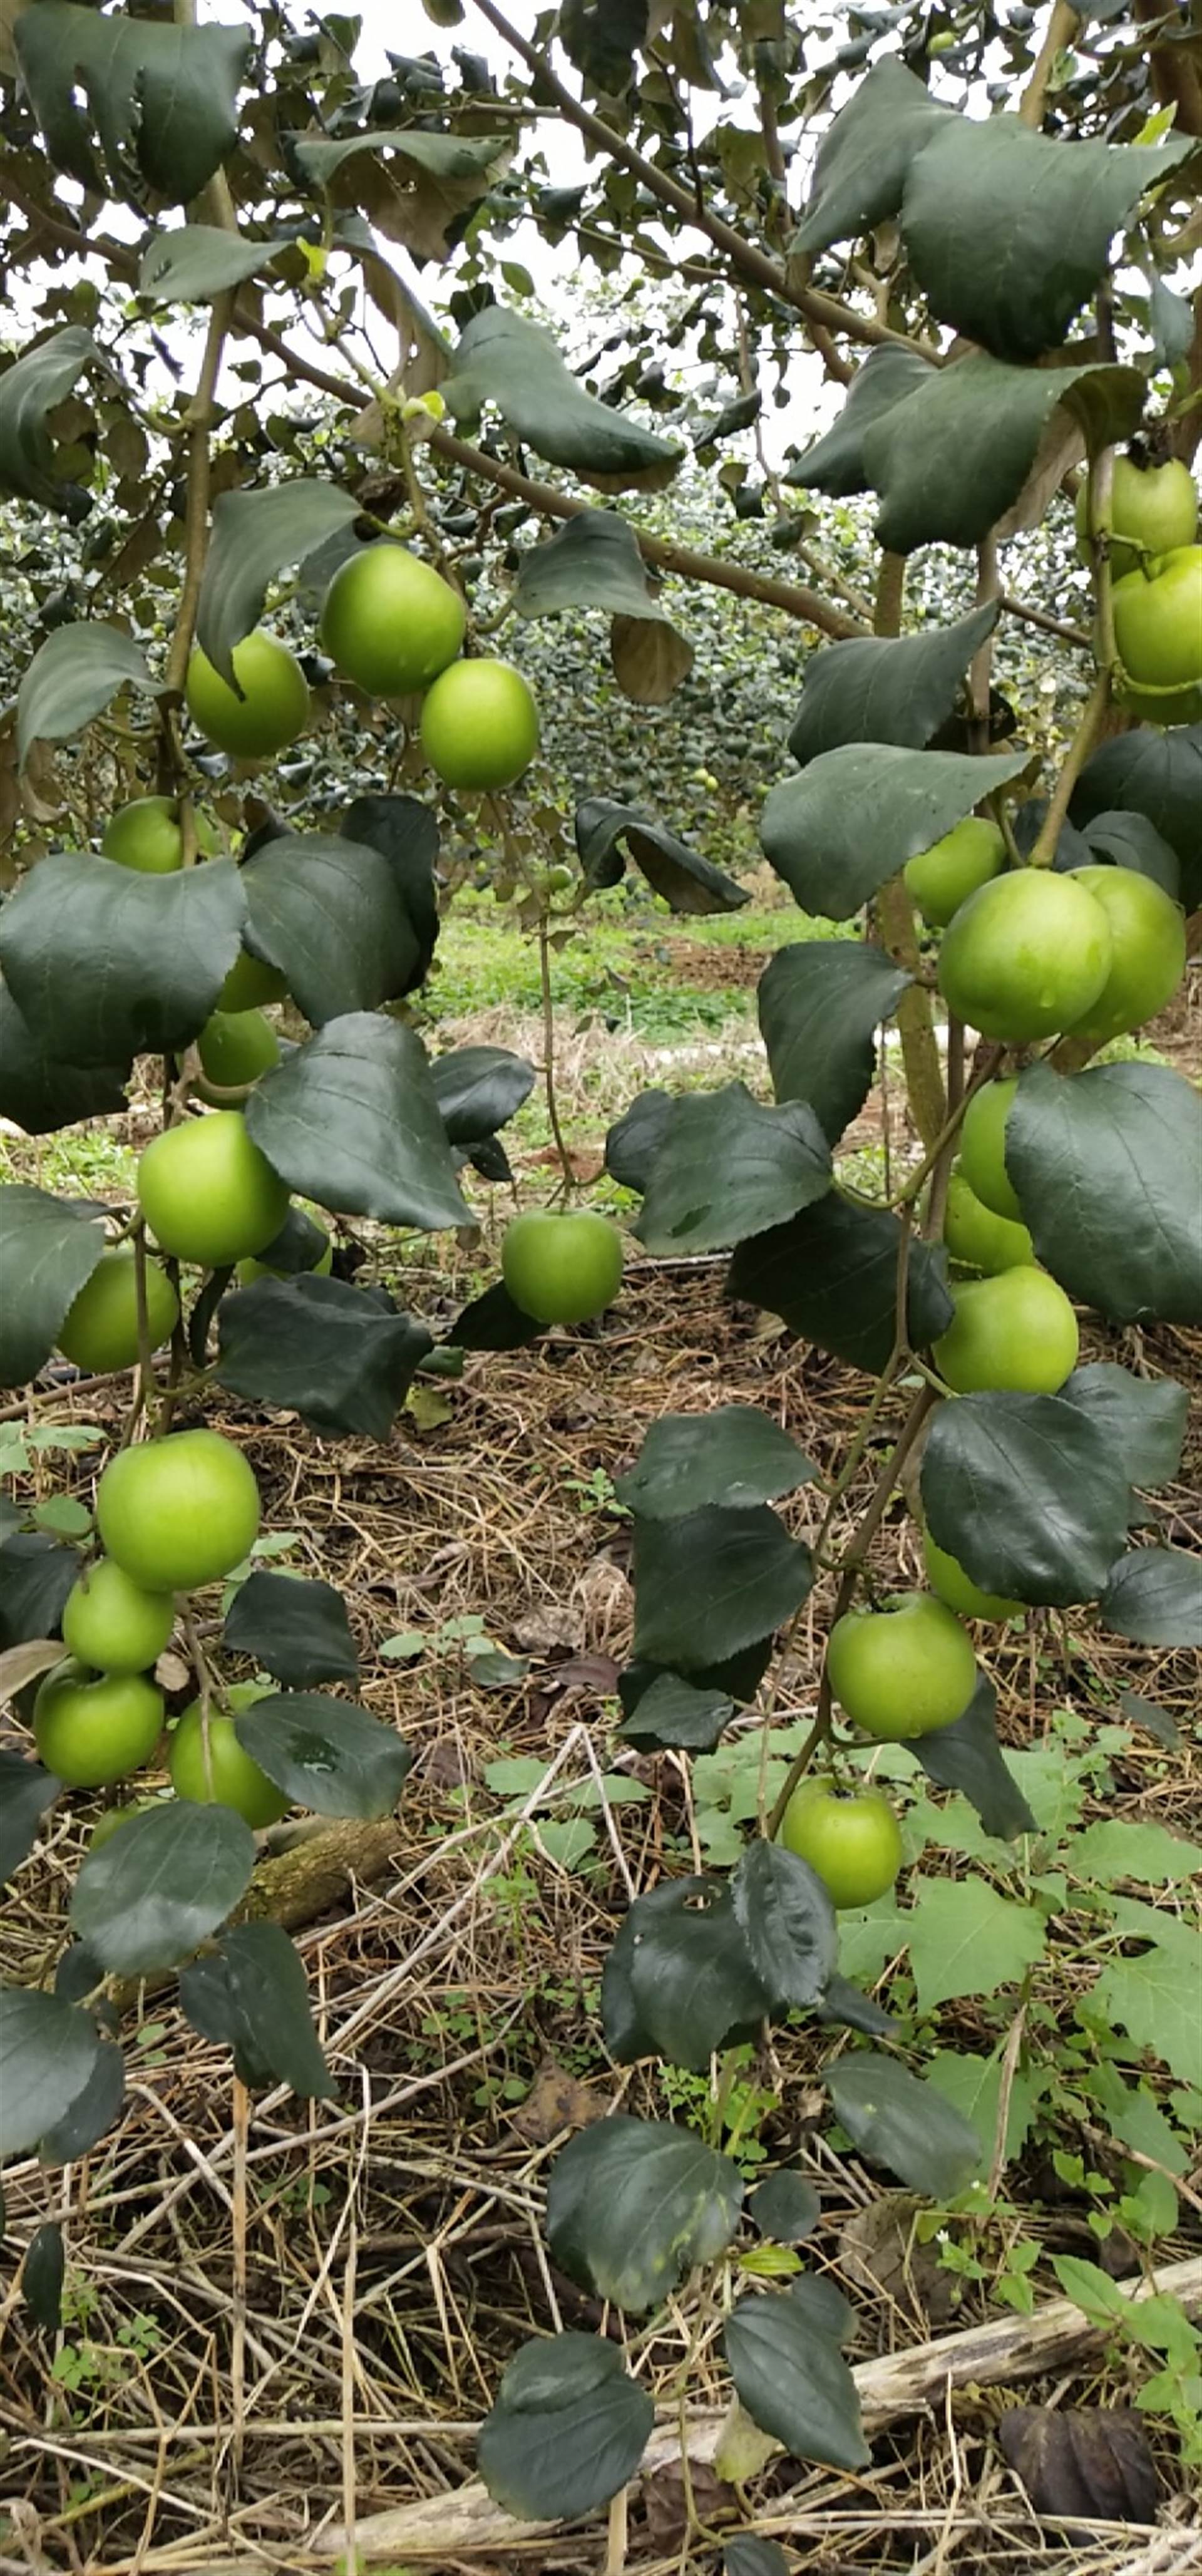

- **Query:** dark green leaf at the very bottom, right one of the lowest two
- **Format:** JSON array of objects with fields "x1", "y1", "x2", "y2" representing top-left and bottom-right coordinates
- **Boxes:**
[{"x1": 723, "y1": 2297, "x2": 870, "y2": 2468}]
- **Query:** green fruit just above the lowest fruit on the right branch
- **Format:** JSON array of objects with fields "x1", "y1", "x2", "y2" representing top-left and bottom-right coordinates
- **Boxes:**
[{"x1": 826, "y1": 1592, "x2": 975, "y2": 1744}]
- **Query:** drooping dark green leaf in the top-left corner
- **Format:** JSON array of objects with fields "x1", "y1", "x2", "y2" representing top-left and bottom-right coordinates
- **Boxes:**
[{"x1": 13, "y1": 0, "x2": 252, "y2": 206}]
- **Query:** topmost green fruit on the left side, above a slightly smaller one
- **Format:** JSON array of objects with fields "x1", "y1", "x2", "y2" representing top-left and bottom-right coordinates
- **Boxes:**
[{"x1": 319, "y1": 538, "x2": 468, "y2": 698}]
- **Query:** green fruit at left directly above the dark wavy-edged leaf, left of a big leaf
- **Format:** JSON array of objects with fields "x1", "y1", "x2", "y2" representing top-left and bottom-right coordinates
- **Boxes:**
[{"x1": 136, "y1": 1110, "x2": 288, "y2": 1270}]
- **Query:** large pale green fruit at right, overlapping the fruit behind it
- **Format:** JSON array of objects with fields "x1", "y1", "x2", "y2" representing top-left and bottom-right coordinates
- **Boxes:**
[{"x1": 940, "y1": 868, "x2": 1112, "y2": 1046}]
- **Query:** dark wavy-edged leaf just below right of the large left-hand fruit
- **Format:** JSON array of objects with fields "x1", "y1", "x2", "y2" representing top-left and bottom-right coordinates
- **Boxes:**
[{"x1": 216, "y1": 1275, "x2": 433, "y2": 1440}]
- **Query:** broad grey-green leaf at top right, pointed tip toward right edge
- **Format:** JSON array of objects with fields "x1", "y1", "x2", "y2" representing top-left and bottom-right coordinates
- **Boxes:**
[{"x1": 901, "y1": 116, "x2": 1194, "y2": 363}]
